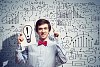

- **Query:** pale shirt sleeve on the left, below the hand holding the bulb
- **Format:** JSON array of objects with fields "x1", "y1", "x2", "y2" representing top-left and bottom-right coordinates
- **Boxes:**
[{"x1": 16, "y1": 44, "x2": 28, "y2": 63}]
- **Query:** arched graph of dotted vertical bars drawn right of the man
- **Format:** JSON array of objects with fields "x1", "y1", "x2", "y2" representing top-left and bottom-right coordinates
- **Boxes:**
[{"x1": 70, "y1": 32, "x2": 93, "y2": 47}]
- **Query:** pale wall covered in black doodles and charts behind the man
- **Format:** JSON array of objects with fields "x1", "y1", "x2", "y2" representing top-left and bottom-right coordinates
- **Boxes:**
[{"x1": 0, "y1": 0, "x2": 100, "y2": 67}]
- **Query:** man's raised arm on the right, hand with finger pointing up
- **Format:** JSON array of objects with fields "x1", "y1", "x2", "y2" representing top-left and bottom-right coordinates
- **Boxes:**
[{"x1": 53, "y1": 29, "x2": 67, "y2": 66}]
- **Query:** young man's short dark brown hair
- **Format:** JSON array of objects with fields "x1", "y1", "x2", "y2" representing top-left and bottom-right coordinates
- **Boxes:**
[{"x1": 35, "y1": 19, "x2": 51, "y2": 32}]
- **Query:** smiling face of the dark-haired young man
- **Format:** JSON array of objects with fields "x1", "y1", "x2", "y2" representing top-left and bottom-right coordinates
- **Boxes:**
[{"x1": 37, "y1": 24, "x2": 49, "y2": 40}]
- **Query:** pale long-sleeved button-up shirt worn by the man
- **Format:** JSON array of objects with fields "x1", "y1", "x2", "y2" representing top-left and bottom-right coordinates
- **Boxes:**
[{"x1": 16, "y1": 39, "x2": 67, "y2": 67}]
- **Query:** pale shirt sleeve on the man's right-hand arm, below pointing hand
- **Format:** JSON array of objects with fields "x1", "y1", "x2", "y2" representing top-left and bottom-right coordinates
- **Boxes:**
[{"x1": 56, "y1": 40, "x2": 67, "y2": 66}]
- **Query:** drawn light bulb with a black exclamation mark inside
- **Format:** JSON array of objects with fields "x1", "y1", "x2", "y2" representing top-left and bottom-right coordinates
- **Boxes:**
[{"x1": 23, "y1": 25, "x2": 32, "y2": 43}]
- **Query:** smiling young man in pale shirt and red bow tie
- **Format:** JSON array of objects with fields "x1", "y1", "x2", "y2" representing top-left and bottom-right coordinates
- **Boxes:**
[{"x1": 16, "y1": 19, "x2": 67, "y2": 67}]
